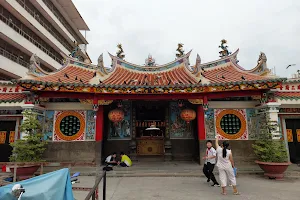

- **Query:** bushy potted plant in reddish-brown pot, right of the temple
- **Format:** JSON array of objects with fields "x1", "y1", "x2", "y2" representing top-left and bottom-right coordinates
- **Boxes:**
[{"x1": 252, "y1": 113, "x2": 291, "y2": 179}]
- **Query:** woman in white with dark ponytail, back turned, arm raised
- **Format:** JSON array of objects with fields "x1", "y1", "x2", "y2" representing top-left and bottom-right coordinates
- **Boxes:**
[{"x1": 216, "y1": 135, "x2": 239, "y2": 195}]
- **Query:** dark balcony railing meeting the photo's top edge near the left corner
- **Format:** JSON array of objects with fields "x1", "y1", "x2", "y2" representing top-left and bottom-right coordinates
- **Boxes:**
[{"x1": 17, "y1": 0, "x2": 73, "y2": 51}]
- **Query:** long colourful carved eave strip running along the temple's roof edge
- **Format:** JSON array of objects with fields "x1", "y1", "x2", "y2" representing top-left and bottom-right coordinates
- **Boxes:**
[{"x1": 18, "y1": 78, "x2": 286, "y2": 94}]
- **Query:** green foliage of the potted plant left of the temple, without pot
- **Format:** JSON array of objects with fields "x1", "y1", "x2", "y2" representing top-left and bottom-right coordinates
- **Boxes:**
[{"x1": 10, "y1": 110, "x2": 46, "y2": 162}]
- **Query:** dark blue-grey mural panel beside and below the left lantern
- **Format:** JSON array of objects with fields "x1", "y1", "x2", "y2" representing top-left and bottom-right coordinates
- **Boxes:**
[{"x1": 108, "y1": 102, "x2": 131, "y2": 140}]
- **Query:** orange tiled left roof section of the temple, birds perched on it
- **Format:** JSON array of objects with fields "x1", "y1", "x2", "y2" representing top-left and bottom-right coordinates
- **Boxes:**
[{"x1": 34, "y1": 65, "x2": 95, "y2": 84}]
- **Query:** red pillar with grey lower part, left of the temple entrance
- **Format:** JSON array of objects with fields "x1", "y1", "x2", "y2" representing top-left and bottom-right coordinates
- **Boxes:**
[{"x1": 95, "y1": 105, "x2": 104, "y2": 166}]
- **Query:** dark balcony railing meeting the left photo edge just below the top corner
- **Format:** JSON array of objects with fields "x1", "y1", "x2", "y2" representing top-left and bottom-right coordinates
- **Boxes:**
[{"x1": 0, "y1": 10, "x2": 62, "y2": 64}]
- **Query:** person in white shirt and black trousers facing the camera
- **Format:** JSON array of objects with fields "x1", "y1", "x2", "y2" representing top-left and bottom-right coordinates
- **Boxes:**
[{"x1": 203, "y1": 140, "x2": 220, "y2": 187}]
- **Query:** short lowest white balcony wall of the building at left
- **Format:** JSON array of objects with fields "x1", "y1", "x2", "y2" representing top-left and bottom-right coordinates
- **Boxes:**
[{"x1": 0, "y1": 55, "x2": 28, "y2": 77}]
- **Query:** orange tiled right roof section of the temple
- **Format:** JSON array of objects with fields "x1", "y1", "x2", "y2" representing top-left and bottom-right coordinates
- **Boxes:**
[{"x1": 203, "y1": 65, "x2": 270, "y2": 83}]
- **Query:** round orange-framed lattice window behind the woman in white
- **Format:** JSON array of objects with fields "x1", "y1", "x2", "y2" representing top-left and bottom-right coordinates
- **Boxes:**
[{"x1": 216, "y1": 110, "x2": 246, "y2": 140}]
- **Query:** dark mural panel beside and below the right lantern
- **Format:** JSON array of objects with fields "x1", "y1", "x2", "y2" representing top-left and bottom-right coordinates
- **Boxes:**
[{"x1": 170, "y1": 102, "x2": 194, "y2": 139}]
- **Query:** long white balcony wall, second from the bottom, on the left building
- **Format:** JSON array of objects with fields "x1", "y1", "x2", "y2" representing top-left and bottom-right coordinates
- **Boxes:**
[{"x1": 0, "y1": 21, "x2": 62, "y2": 69}]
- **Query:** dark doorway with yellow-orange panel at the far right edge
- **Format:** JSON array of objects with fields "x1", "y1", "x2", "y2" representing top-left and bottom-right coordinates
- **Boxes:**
[{"x1": 285, "y1": 119, "x2": 300, "y2": 164}]
